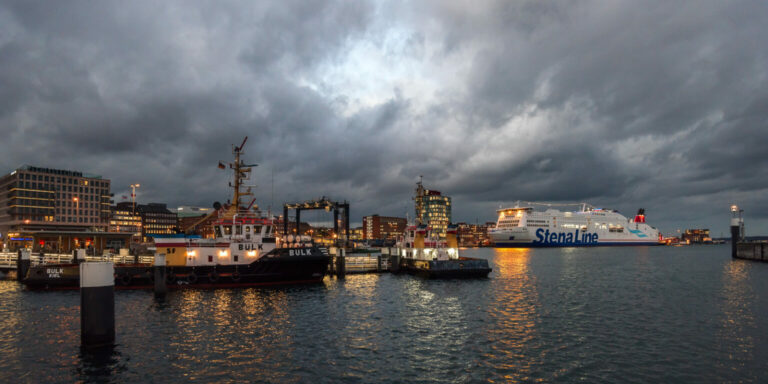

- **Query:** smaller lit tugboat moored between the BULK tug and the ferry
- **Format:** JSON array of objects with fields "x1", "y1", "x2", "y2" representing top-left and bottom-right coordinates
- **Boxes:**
[{"x1": 396, "y1": 182, "x2": 492, "y2": 278}]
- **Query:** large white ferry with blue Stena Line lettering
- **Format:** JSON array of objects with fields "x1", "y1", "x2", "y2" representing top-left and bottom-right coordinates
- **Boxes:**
[{"x1": 489, "y1": 202, "x2": 659, "y2": 248}]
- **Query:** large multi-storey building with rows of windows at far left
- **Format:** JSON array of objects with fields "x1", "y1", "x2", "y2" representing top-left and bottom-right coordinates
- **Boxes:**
[{"x1": 0, "y1": 165, "x2": 112, "y2": 233}]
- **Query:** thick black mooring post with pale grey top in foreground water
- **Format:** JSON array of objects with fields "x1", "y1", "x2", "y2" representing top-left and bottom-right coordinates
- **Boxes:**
[{"x1": 80, "y1": 261, "x2": 115, "y2": 348}]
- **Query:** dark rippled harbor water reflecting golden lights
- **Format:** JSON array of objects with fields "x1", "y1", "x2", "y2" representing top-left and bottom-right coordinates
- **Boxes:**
[{"x1": 0, "y1": 245, "x2": 768, "y2": 383}]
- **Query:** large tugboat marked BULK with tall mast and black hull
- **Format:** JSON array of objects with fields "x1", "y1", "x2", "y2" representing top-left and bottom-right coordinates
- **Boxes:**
[{"x1": 22, "y1": 137, "x2": 330, "y2": 289}]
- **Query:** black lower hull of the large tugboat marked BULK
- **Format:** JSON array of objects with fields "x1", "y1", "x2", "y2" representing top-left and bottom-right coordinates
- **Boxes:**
[{"x1": 23, "y1": 249, "x2": 329, "y2": 290}]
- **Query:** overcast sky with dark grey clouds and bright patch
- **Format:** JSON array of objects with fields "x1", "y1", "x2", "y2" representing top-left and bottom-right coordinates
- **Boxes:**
[{"x1": 0, "y1": 0, "x2": 768, "y2": 236}]
